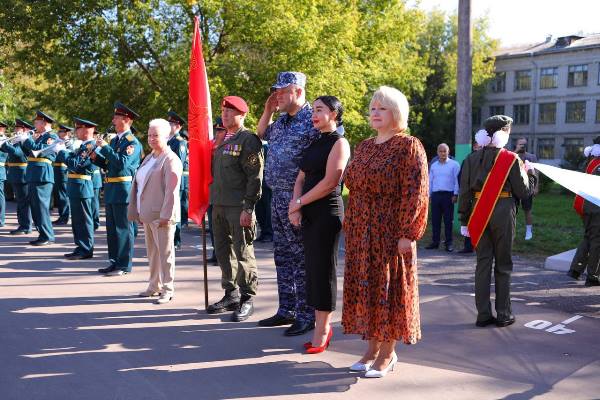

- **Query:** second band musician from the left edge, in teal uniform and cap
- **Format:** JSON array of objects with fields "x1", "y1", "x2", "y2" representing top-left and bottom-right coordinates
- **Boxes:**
[{"x1": 0, "y1": 118, "x2": 33, "y2": 235}]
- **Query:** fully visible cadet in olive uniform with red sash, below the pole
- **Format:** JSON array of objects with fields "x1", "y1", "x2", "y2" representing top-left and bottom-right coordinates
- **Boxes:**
[{"x1": 458, "y1": 115, "x2": 536, "y2": 327}]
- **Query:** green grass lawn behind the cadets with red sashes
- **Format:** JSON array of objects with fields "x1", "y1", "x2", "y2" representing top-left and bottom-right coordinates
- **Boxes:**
[{"x1": 343, "y1": 184, "x2": 583, "y2": 259}]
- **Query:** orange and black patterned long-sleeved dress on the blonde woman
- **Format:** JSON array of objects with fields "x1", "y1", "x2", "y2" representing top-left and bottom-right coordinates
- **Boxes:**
[{"x1": 342, "y1": 134, "x2": 429, "y2": 344}]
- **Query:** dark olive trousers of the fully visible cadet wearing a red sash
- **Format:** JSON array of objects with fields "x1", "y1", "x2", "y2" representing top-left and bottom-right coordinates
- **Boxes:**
[{"x1": 475, "y1": 197, "x2": 516, "y2": 321}]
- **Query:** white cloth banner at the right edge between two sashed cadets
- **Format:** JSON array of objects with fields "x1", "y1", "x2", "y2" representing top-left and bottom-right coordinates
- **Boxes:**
[{"x1": 531, "y1": 163, "x2": 600, "y2": 207}]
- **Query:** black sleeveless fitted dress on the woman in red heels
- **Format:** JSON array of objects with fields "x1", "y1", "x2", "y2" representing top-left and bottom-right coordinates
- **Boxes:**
[{"x1": 300, "y1": 132, "x2": 344, "y2": 311}]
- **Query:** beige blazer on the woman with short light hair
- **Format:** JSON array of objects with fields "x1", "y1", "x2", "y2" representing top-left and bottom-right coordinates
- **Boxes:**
[{"x1": 127, "y1": 148, "x2": 183, "y2": 224}]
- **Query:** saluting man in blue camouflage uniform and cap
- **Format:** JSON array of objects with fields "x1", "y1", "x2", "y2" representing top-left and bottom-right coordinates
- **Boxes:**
[{"x1": 257, "y1": 72, "x2": 319, "y2": 336}]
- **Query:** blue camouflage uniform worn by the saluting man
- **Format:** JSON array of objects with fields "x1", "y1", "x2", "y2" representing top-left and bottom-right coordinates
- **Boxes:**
[{"x1": 259, "y1": 79, "x2": 320, "y2": 334}]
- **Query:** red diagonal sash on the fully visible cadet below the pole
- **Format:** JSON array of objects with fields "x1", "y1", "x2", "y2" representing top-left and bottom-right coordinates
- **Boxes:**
[{"x1": 468, "y1": 149, "x2": 517, "y2": 247}]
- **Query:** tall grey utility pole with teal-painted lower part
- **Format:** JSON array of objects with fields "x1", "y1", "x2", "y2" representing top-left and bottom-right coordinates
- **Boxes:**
[{"x1": 454, "y1": 0, "x2": 473, "y2": 163}]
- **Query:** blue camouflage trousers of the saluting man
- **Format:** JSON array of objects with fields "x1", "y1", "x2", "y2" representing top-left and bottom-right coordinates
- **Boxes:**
[{"x1": 271, "y1": 190, "x2": 315, "y2": 322}]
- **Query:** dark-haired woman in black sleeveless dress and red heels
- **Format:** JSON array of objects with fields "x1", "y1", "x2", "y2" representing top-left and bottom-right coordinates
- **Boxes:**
[{"x1": 289, "y1": 96, "x2": 350, "y2": 354}]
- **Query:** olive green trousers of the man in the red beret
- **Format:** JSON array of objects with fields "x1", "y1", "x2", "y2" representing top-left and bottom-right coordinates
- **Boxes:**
[{"x1": 212, "y1": 205, "x2": 258, "y2": 296}]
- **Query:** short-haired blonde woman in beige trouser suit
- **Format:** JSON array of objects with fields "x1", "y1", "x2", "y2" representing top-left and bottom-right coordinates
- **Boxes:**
[{"x1": 127, "y1": 119, "x2": 183, "y2": 304}]
